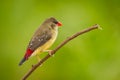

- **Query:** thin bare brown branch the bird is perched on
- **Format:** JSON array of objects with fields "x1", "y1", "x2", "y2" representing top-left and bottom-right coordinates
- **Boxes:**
[{"x1": 22, "y1": 24, "x2": 102, "y2": 80}]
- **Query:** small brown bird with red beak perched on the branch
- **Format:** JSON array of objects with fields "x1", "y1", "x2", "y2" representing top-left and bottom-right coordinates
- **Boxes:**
[{"x1": 19, "y1": 17, "x2": 62, "y2": 66}]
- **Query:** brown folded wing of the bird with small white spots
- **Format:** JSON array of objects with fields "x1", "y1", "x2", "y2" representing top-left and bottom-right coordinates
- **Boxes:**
[{"x1": 28, "y1": 30, "x2": 52, "y2": 51}]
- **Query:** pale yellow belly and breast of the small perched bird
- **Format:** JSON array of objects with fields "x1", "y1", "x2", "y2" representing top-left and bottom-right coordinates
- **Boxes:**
[{"x1": 31, "y1": 29, "x2": 58, "y2": 56}]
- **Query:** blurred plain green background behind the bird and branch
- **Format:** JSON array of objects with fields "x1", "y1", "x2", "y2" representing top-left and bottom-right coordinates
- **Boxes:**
[{"x1": 0, "y1": 0, "x2": 120, "y2": 80}]
